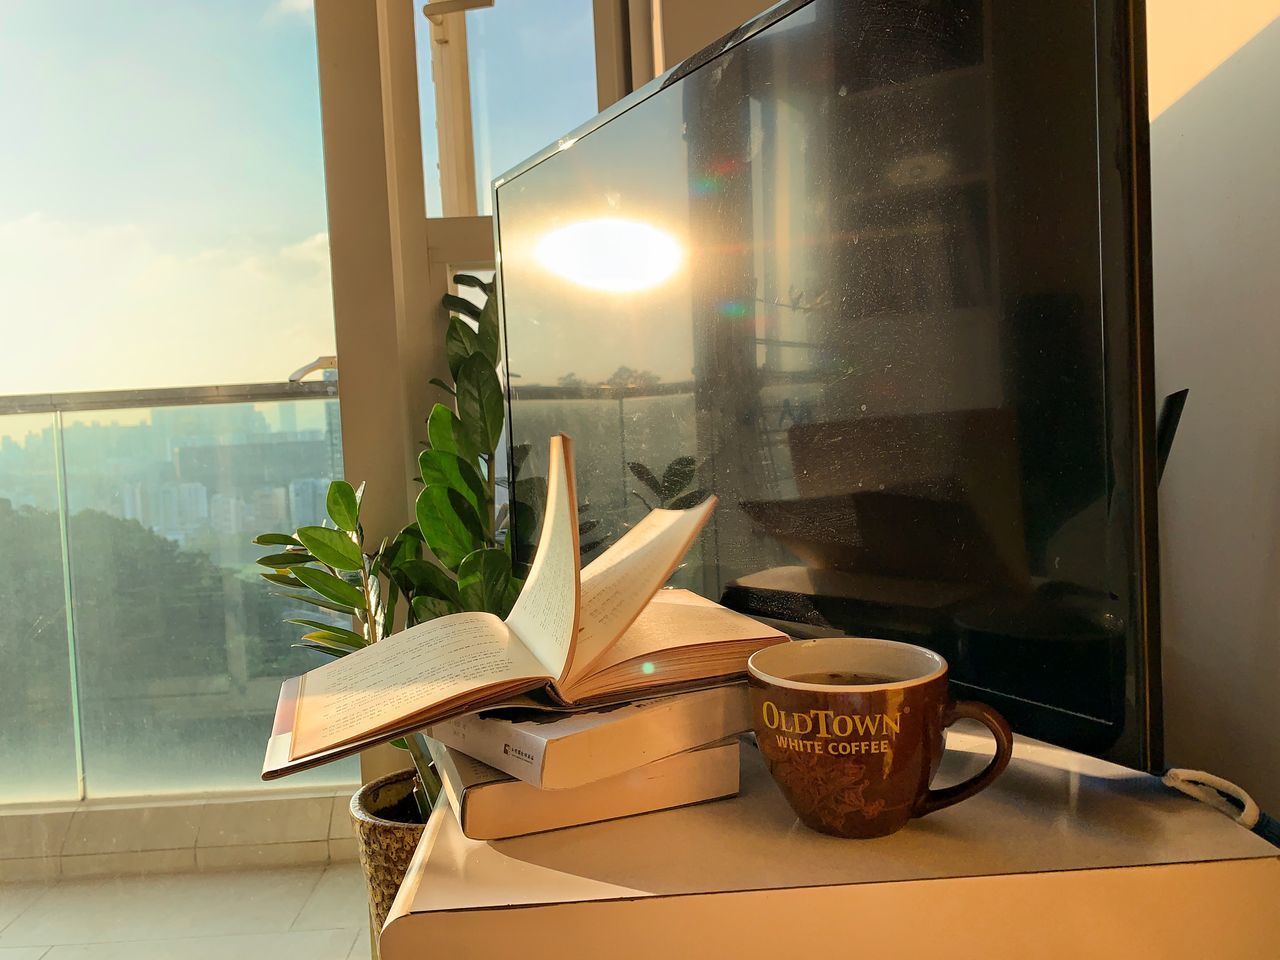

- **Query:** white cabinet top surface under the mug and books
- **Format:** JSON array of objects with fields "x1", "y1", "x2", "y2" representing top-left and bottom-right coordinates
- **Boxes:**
[{"x1": 388, "y1": 728, "x2": 1277, "y2": 924}]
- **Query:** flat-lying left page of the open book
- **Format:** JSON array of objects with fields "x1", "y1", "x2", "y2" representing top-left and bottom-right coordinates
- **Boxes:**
[{"x1": 289, "y1": 613, "x2": 550, "y2": 759}]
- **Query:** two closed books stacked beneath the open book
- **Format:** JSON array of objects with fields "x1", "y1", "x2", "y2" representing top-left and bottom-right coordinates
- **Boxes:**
[{"x1": 413, "y1": 684, "x2": 751, "y2": 840}]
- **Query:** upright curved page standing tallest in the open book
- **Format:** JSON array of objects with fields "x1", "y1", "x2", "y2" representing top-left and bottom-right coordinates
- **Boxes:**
[{"x1": 507, "y1": 434, "x2": 580, "y2": 680}]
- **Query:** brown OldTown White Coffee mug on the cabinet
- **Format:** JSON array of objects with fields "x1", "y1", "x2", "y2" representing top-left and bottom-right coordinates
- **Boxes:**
[{"x1": 748, "y1": 637, "x2": 1014, "y2": 837}]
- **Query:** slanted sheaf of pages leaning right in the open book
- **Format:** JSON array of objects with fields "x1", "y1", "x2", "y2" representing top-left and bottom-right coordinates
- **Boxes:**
[{"x1": 568, "y1": 497, "x2": 716, "y2": 684}]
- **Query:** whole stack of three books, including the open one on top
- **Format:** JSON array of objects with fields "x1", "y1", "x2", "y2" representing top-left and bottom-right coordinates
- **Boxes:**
[{"x1": 262, "y1": 436, "x2": 787, "y2": 838}]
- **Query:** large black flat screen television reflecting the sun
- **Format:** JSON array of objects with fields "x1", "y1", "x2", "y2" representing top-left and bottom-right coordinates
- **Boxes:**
[{"x1": 494, "y1": 0, "x2": 1161, "y2": 769}]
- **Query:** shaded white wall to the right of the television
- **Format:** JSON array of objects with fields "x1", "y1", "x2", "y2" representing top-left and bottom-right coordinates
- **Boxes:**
[{"x1": 1149, "y1": 16, "x2": 1280, "y2": 813}]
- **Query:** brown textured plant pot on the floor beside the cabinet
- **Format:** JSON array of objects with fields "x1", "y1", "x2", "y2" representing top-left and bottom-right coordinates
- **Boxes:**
[{"x1": 351, "y1": 769, "x2": 425, "y2": 931}]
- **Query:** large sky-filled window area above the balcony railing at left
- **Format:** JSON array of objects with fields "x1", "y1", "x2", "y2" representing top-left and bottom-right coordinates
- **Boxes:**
[{"x1": 0, "y1": 0, "x2": 334, "y2": 394}]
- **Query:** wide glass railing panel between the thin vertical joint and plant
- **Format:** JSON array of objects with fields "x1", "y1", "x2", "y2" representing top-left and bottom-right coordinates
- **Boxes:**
[{"x1": 65, "y1": 399, "x2": 357, "y2": 796}]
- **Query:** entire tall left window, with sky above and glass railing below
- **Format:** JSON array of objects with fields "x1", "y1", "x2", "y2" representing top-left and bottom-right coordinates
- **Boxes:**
[{"x1": 0, "y1": 0, "x2": 355, "y2": 804}]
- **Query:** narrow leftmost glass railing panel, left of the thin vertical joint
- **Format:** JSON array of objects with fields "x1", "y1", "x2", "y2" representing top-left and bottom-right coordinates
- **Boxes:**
[{"x1": 0, "y1": 413, "x2": 79, "y2": 804}]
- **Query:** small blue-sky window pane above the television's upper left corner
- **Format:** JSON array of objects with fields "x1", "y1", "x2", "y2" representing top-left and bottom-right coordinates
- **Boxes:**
[{"x1": 467, "y1": 0, "x2": 596, "y2": 214}]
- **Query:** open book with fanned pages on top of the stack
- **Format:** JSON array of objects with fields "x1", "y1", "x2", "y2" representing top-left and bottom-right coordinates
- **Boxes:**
[{"x1": 262, "y1": 436, "x2": 786, "y2": 778}]
